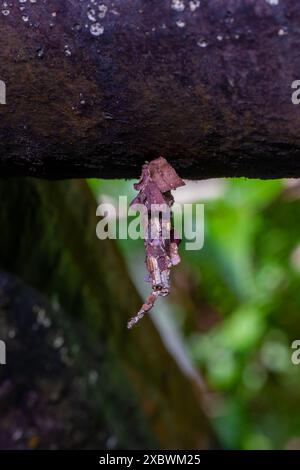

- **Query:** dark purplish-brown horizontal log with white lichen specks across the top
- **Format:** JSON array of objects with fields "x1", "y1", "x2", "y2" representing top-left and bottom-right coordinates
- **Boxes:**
[{"x1": 0, "y1": 0, "x2": 300, "y2": 178}]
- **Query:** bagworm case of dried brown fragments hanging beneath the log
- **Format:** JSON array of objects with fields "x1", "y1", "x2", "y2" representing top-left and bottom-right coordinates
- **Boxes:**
[{"x1": 127, "y1": 157, "x2": 185, "y2": 328}]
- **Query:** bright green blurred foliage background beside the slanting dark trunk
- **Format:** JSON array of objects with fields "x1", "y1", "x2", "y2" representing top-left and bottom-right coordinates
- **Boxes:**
[{"x1": 88, "y1": 179, "x2": 300, "y2": 449}]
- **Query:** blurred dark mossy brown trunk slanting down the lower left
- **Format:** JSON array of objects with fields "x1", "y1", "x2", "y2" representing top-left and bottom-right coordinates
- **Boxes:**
[{"x1": 0, "y1": 179, "x2": 214, "y2": 449}]
